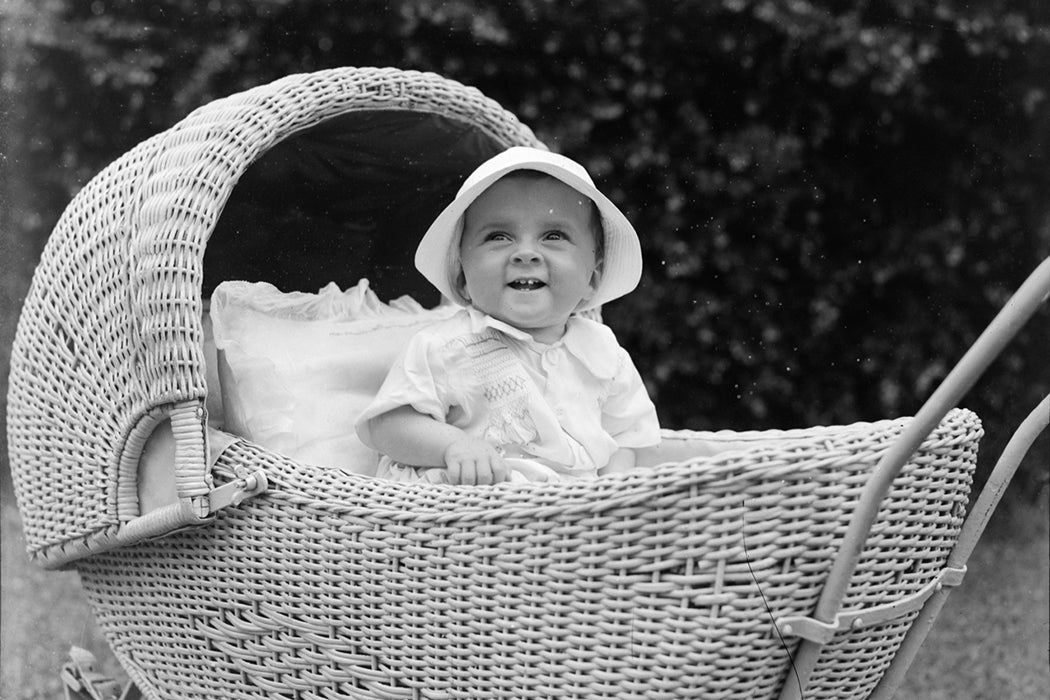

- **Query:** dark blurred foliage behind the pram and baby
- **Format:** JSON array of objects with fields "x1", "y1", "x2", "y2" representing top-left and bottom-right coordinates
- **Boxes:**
[{"x1": 0, "y1": 0, "x2": 1050, "y2": 497}]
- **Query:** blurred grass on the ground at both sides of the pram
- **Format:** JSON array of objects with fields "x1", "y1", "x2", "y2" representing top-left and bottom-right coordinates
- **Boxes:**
[{"x1": 0, "y1": 484, "x2": 1050, "y2": 700}]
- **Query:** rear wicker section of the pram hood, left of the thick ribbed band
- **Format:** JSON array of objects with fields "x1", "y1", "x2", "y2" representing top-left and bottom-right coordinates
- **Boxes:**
[{"x1": 7, "y1": 138, "x2": 157, "y2": 554}]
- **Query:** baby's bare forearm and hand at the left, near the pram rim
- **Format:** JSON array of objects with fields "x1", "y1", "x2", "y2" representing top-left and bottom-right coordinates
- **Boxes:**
[{"x1": 369, "y1": 406, "x2": 507, "y2": 486}]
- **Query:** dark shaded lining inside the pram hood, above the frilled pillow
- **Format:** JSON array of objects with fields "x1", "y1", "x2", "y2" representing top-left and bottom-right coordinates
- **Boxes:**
[{"x1": 203, "y1": 109, "x2": 505, "y2": 306}]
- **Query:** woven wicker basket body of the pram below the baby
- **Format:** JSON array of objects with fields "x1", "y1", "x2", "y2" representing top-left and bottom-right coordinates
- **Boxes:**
[{"x1": 79, "y1": 410, "x2": 981, "y2": 700}]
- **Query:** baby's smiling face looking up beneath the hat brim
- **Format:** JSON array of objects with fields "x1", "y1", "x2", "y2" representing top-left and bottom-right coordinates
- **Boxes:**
[{"x1": 460, "y1": 174, "x2": 597, "y2": 343}]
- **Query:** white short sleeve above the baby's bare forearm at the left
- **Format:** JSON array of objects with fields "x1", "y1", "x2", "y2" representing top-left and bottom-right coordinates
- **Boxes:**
[{"x1": 355, "y1": 331, "x2": 448, "y2": 447}]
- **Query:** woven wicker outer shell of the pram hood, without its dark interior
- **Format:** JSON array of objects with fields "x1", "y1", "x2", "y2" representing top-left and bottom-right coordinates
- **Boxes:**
[{"x1": 7, "y1": 68, "x2": 539, "y2": 566}]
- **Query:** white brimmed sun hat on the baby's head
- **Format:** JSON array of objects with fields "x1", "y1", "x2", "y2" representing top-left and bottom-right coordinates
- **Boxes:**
[{"x1": 416, "y1": 146, "x2": 642, "y2": 311}]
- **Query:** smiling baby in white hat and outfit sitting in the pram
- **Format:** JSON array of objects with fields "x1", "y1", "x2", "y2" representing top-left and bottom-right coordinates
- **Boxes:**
[{"x1": 357, "y1": 147, "x2": 659, "y2": 485}]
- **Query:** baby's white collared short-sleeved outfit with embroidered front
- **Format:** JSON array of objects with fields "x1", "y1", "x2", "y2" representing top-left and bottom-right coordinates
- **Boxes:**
[{"x1": 357, "y1": 309, "x2": 659, "y2": 482}]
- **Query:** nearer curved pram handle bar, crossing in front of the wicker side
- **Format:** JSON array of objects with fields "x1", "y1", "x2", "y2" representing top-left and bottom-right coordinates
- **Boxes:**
[{"x1": 780, "y1": 258, "x2": 1050, "y2": 700}]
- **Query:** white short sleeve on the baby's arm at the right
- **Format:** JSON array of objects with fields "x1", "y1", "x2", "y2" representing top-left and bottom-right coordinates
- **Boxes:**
[{"x1": 602, "y1": 346, "x2": 660, "y2": 448}]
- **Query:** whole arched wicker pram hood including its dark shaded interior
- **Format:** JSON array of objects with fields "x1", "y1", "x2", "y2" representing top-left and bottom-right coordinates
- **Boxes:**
[{"x1": 8, "y1": 68, "x2": 543, "y2": 567}]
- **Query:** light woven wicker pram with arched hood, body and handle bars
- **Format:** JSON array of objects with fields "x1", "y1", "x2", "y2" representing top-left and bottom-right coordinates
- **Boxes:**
[{"x1": 8, "y1": 68, "x2": 1050, "y2": 699}]
